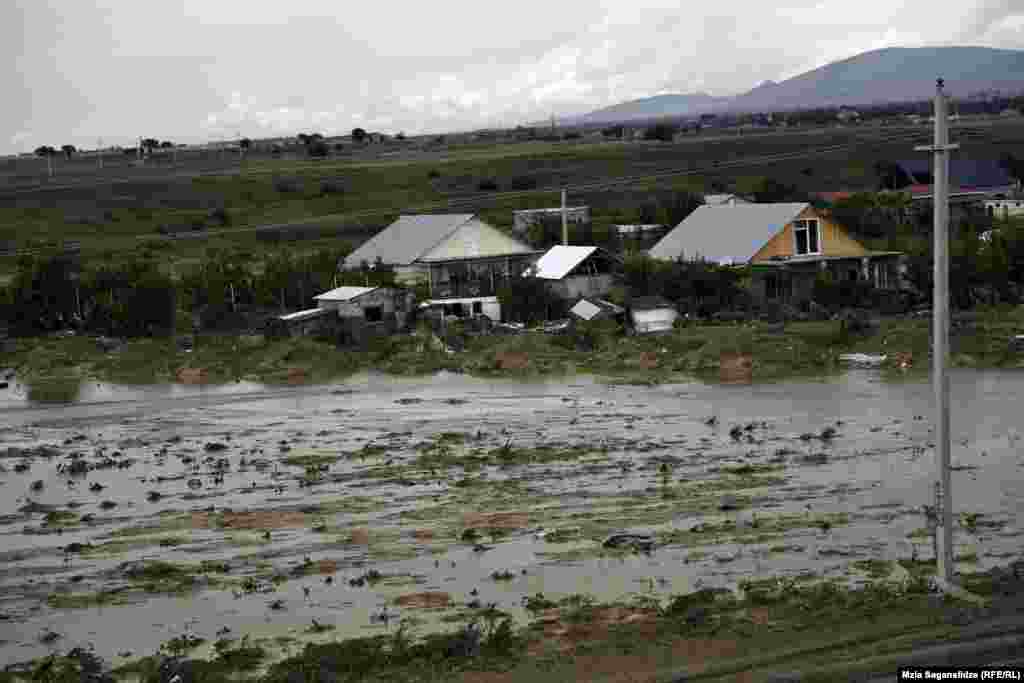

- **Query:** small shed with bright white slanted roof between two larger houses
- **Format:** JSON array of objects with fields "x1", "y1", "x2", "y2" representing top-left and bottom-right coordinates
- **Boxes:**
[{"x1": 526, "y1": 245, "x2": 620, "y2": 299}]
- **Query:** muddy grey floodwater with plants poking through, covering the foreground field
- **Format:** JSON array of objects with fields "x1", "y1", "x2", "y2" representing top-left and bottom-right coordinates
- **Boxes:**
[{"x1": 0, "y1": 371, "x2": 1024, "y2": 664}]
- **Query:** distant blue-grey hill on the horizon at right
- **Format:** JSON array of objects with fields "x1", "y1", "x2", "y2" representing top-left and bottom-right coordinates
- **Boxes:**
[{"x1": 566, "y1": 47, "x2": 1024, "y2": 123}]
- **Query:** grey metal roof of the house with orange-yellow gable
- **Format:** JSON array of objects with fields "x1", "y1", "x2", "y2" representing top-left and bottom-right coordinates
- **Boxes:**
[{"x1": 648, "y1": 203, "x2": 810, "y2": 263}]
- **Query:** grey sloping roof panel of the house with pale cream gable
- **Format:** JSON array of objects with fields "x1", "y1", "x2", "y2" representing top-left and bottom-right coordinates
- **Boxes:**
[{"x1": 345, "y1": 213, "x2": 473, "y2": 267}]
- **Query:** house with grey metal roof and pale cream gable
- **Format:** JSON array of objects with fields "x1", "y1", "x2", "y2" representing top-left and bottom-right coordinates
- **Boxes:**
[{"x1": 343, "y1": 213, "x2": 540, "y2": 321}]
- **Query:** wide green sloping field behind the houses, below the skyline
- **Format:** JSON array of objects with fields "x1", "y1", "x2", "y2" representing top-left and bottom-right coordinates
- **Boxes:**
[{"x1": 0, "y1": 122, "x2": 1024, "y2": 280}]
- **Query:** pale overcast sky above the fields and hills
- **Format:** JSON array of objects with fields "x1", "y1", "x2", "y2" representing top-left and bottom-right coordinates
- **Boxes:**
[{"x1": 0, "y1": 0, "x2": 1024, "y2": 154}]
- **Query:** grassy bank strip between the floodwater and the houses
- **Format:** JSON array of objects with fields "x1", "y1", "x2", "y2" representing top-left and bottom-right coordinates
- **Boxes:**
[{"x1": 4, "y1": 309, "x2": 1024, "y2": 386}]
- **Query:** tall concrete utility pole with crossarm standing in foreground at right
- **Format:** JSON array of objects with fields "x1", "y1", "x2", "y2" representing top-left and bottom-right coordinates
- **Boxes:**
[{"x1": 915, "y1": 78, "x2": 959, "y2": 588}]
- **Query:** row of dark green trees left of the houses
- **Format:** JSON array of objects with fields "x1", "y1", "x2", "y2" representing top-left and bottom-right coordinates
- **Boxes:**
[{"x1": 0, "y1": 245, "x2": 356, "y2": 337}]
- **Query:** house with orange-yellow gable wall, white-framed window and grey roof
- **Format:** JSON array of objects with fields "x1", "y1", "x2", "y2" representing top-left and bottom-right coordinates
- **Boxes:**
[{"x1": 649, "y1": 203, "x2": 903, "y2": 304}]
